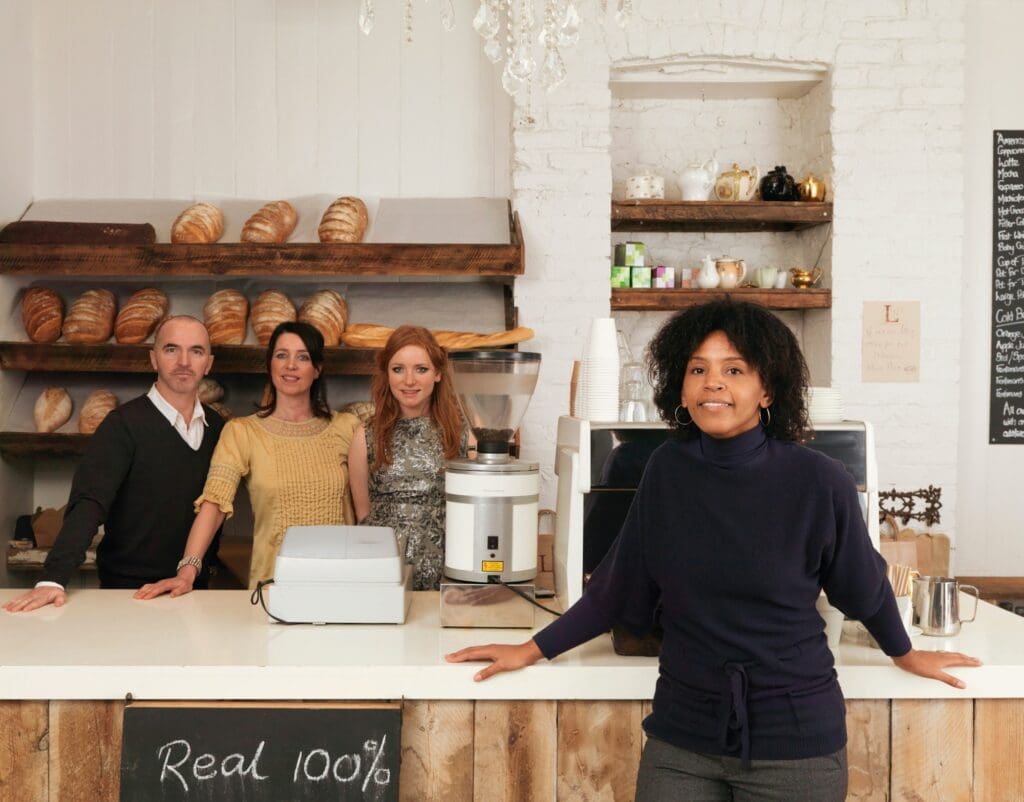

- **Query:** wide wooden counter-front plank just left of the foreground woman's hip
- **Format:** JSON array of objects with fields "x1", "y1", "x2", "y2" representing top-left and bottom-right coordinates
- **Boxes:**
[{"x1": 557, "y1": 701, "x2": 641, "y2": 802}]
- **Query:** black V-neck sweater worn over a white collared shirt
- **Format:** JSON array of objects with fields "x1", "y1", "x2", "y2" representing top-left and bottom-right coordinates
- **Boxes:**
[{"x1": 43, "y1": 395, "x2": 224, "y2": 585}]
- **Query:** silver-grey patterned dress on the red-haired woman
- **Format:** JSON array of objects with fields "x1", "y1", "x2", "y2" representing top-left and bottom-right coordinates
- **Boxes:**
[{"x1": 362, "y1": 415, "x2": 454, "y2": 590}]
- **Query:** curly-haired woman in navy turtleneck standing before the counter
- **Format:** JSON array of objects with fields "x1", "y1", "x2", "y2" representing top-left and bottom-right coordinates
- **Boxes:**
[{"x1": 449, "y1": 300, "x2": 978, "y2": 802}]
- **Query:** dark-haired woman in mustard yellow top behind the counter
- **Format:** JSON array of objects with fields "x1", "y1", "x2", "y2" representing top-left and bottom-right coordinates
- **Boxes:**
[{"x1": 135, "y1": 323, "x2": 359, "y2": 599}]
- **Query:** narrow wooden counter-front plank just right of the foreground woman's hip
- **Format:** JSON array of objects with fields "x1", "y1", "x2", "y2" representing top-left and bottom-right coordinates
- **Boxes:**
[{"x1": 846, "y1": 700, "x2": 890, "y2": 802}]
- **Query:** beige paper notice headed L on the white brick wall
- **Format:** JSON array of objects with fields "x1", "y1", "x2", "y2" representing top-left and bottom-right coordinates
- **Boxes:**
[{"x1": 861, "y1": 301, "x2": 921, "y2": 382}]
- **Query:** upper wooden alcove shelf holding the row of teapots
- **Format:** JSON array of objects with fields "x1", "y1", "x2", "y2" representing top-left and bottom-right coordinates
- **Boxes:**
[{"x1": 611, "y1": 201, "x2": 833, "y2": 231}]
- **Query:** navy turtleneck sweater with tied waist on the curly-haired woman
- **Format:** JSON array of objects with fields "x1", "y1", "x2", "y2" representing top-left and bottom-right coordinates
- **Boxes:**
[{"x1": 535, "y1": 426, "x2": 910, "y2": 763}]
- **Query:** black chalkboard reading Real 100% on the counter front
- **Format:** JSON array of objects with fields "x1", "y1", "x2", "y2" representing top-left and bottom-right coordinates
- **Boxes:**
[{"x1": 121, "y1": 704, "x2": 401, "y2": 802}]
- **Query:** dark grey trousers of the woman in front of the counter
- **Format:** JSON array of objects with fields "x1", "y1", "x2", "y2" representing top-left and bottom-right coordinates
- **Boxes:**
[{"x1": 636, "y1": 737, "x2": 847, "y2": 802}]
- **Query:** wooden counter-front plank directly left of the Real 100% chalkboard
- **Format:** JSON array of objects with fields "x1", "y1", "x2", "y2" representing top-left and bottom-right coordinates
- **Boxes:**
[{"x1": 49, "y1": 701, "x2": 124, "y2": 802}]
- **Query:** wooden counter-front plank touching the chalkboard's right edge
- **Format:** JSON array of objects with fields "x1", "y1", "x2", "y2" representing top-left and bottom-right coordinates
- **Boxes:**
[{"x1": 399, "y1": 701, "x2": 473, "y2": 802}]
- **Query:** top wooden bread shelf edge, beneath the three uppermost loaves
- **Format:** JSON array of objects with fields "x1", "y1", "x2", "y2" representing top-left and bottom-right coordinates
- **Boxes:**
[{"x1": 0, "y1": 209, "x2": 525, "y2": 281}]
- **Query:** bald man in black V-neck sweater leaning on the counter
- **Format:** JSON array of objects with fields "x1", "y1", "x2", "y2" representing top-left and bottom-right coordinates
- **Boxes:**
[{"x1": 4, "y1": 315, "x2": 223, "y2": 613}]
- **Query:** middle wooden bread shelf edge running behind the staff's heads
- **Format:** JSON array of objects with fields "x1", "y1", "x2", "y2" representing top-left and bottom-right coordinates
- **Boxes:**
[{"x1": 0, "y1": 342, "x2": 377, "y2": 376}]
